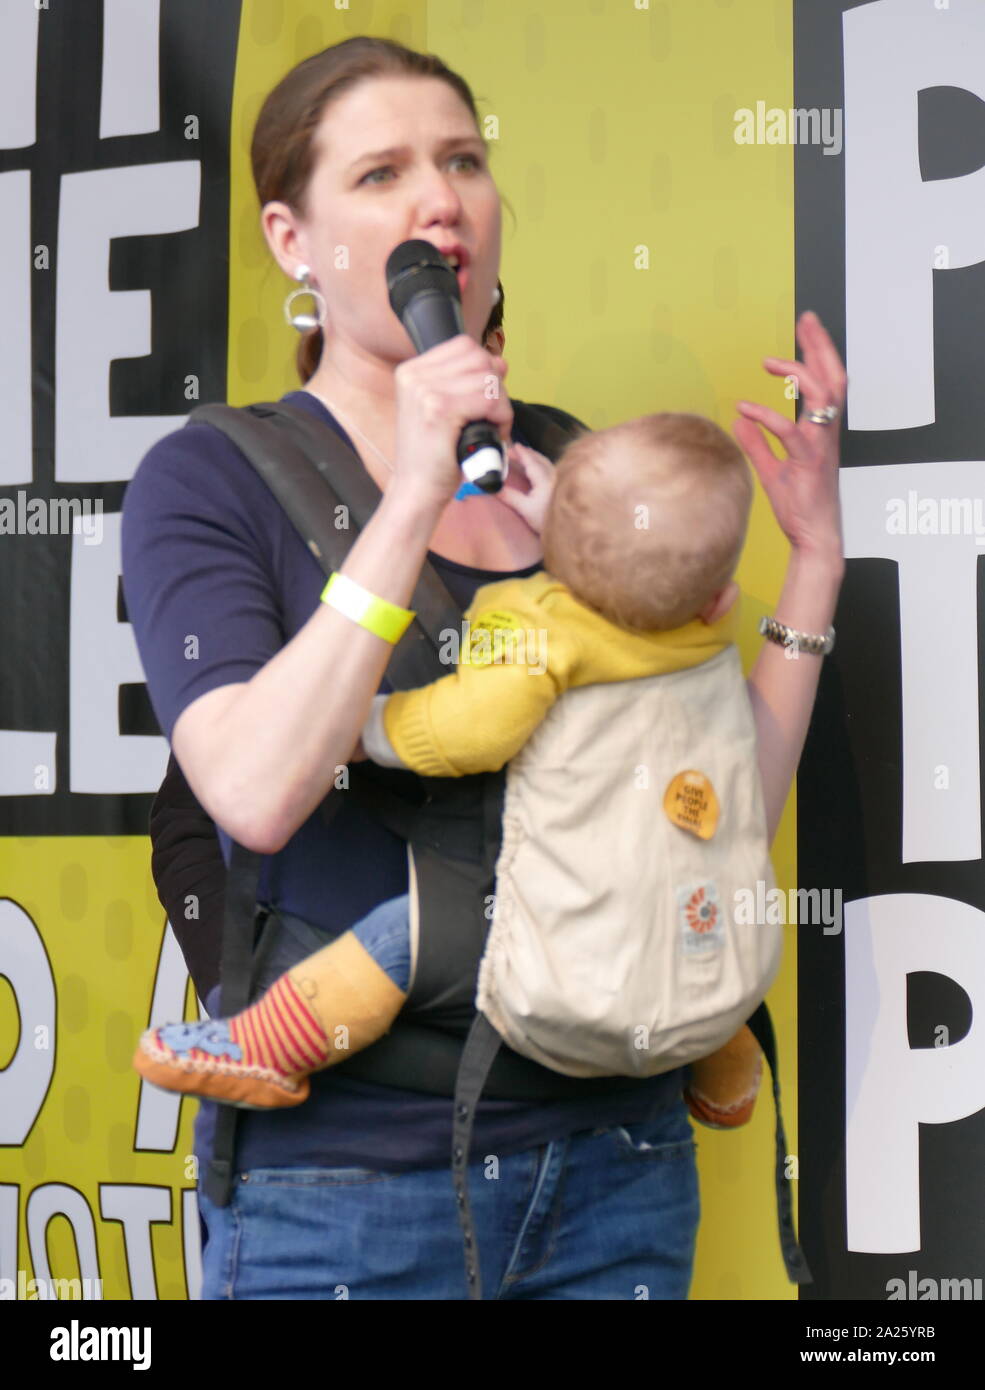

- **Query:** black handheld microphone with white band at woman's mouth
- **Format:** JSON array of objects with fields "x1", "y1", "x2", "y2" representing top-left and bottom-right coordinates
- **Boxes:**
[{"x1": 386, "y1": 240, "x2": 508, "y2": 498}]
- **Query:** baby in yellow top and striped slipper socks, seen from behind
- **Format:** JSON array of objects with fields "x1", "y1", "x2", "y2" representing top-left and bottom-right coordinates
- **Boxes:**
[{"x1": 133, "y1": 414, "x2": 763, "y2": 1127}]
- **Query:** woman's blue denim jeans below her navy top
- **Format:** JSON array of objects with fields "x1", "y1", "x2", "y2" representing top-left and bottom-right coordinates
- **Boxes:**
[{"x1": 199, "y1": 1101, "x2": 699, "y2": 1300}]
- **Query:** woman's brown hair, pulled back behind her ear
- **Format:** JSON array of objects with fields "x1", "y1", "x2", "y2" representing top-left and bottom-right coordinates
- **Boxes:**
[{"x1": 250, "y1": 36, "x2": 479, "y2": 382}]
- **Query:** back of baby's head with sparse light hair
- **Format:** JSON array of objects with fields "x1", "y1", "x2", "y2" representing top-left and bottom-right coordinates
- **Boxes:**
[{"x1": 543, "y1": 413, "x2": 753, "y2": 631}]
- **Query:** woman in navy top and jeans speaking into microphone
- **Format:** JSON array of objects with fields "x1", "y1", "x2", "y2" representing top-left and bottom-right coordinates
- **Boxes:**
[{"x1": 122, "y1": 38, "x2": 845, "y2": 1300}]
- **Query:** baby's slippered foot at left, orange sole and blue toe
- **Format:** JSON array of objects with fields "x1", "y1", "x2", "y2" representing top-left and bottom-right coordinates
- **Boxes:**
[{"x1": 133, "y1": 1019, "x2": 311, "y2": 1111}]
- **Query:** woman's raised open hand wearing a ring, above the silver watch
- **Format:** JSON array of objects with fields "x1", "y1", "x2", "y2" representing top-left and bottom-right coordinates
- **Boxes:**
[{"x1": 732, "y1": 313, "x2": 847, "y2": 563}]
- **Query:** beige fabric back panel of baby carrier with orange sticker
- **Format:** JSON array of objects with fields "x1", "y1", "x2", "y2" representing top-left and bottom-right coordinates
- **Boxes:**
[{"x1": 477, "y1": 646, "x2": 781, "y2": 1076}]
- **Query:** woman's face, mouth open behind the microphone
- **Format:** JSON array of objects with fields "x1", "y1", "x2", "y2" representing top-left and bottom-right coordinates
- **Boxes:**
[{"x1": 282, "y1": 76, "x2": 500, "y2": 361}]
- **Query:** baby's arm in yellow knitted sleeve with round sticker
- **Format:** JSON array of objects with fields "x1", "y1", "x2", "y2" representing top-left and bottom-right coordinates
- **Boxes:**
[{"x1": 363, "y1": 595, "x2": 575, "y2": 777}]
